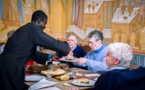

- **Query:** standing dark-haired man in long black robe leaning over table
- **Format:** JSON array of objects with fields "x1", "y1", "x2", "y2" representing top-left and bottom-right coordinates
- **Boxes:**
[{"x1": 0, "y1": 10, "x2": 69, "y2": 90}]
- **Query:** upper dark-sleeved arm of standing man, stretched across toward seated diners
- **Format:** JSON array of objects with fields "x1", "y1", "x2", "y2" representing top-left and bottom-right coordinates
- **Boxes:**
[{"x1": 32, "y1": 27, "x2": 69, "y2": 56}]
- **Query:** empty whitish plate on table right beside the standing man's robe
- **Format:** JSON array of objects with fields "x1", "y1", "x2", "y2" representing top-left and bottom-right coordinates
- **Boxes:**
[{"x1": 25, "y1": 75, "x2": 45, "y2": 82}]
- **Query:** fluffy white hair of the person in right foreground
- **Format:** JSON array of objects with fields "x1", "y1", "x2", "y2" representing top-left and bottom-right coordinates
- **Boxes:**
[{"x1": 108, "y1": 42, "x2": 133, "y2": 68}]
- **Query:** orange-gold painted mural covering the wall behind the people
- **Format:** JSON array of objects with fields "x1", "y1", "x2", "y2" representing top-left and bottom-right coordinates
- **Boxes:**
[{"x1": 0, "y1": 0, "x2": 145, "y2": 50}]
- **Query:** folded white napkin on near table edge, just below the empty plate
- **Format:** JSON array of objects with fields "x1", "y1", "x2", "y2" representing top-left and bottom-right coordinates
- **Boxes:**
[{"x1": 28, "y1": 78, "x2": 58, "y2": 90}]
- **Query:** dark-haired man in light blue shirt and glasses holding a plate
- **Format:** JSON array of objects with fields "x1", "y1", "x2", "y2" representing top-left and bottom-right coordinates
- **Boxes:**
[{"x1": 74, "y1": 30, "x2": 109, "y2": 72}]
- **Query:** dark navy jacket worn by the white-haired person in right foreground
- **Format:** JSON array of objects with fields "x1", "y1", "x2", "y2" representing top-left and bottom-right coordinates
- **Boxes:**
[{"x1": 93, "y1": 67, "x2": 145, "y2": 90}]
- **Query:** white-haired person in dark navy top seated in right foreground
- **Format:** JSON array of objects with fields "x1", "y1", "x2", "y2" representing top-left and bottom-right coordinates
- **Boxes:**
[{"x1": 93, "y1": 42, "x2": 145, "y2": 90}]
